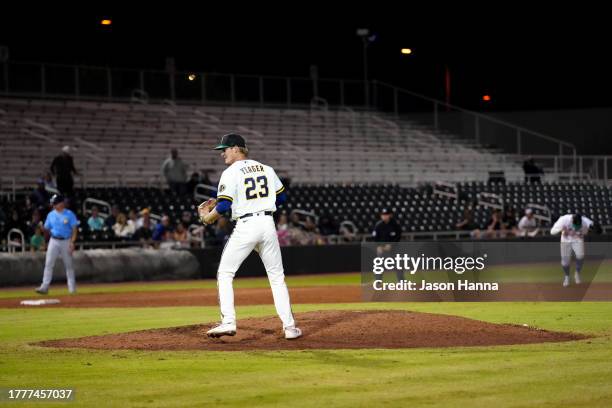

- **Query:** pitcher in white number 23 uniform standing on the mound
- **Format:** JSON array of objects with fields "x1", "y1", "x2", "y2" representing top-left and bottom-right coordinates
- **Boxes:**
[{"x1": 198, "y1": 133, "x2": 302, "y2": 339}]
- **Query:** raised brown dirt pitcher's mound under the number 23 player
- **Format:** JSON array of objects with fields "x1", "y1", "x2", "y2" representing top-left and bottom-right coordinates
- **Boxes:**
[{"x1": 38, "y1": 310, "x2": 587, "y2": 351}]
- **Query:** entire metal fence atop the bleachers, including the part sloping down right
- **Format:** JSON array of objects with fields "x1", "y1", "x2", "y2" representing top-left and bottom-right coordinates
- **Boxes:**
[{"x1": 0, "y1": 61, "x2": 596, "y2": 180}]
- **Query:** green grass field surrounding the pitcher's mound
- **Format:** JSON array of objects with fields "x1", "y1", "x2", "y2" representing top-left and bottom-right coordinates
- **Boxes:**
[{"x1": 0, "y1": 274, "x2": 612, "y2": 408}]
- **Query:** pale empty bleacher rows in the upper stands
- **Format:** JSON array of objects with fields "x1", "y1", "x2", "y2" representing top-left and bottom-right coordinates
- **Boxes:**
[{"x1": 0, "y1": 98, "x2": 522, "y2": 186}]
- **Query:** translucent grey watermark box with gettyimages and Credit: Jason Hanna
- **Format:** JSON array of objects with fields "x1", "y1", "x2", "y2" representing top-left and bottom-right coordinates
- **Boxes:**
[{"x1": 361, "y1": 240, "x2": 612, "y2": 302}]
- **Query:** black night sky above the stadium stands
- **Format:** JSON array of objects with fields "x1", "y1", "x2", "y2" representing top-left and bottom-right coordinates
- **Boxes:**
[{"x1": 0, "y1": 6, "x2": 612, "y2": 110}]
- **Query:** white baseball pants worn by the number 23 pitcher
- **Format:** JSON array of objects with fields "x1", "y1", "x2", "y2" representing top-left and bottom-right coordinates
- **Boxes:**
[{"x1": 217, "y1": 212, "x2": 295, "y2": 328}]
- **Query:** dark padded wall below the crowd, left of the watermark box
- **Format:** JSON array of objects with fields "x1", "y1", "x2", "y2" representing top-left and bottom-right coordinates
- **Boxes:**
[{"x1": 0, "y1": 244, "x2": 360, "y2": 287}]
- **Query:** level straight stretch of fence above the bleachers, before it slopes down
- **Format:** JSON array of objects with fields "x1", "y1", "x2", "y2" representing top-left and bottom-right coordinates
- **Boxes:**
[{"x1": 0, "y1": 61, "x2": 366, "y2": 107}]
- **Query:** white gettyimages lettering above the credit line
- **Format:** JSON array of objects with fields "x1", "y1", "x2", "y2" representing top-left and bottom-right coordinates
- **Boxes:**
[{"x1": 372, "y1": 254, "x2": 487, "y2": 275}]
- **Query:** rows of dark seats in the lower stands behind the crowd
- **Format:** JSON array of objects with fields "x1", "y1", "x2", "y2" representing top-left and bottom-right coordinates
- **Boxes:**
[{"x1": 58, "y1": 182, "x2": 612, "y2": 233}]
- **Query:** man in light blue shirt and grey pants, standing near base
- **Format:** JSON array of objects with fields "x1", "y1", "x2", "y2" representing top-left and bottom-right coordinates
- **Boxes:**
[{"x1": 36, "y1": 194, "x2": 79, "y2": 295}]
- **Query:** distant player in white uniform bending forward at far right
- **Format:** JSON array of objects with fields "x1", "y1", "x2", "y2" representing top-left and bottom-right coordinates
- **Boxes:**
[{"x1": 550, "y1": 214, "x2": 593, "y2": 287}]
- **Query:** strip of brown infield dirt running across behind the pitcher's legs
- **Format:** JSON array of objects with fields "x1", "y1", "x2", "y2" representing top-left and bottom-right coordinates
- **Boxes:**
[{"x1": 0, "y1": 282, "x2": 612, "y2": 308}]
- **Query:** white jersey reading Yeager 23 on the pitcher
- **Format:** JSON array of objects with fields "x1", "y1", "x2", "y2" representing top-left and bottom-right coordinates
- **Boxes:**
[{"x1": 217, "y1": 159, "x2": 285, "y2": 220}]
